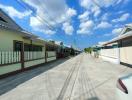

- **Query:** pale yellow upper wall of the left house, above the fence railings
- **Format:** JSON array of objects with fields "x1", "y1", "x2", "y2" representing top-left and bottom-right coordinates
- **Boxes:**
[{"x1": 0, "y1": 29, "x2": 45, "y2": 51}]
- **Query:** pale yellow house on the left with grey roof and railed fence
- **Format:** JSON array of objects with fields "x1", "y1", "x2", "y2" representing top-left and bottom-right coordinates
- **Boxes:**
[{"x1": 0, "y1": 9, "x2": 56, "y2": 77}]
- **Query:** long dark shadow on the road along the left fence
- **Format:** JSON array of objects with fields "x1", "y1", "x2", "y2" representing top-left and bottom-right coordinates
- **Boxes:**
[{"x1": 0, "y1": 57, "x2": 71, "y2": 95}]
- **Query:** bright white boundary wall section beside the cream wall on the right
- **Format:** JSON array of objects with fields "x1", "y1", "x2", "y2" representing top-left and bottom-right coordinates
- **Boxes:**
[{"x1": 99, "y1": 48, "x2": 120, "y2": 64}]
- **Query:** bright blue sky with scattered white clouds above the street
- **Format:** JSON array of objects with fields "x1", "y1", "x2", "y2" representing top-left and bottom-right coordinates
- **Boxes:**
[{"x1": 0, "y1": 0, "x2": 132, "y2": 49}]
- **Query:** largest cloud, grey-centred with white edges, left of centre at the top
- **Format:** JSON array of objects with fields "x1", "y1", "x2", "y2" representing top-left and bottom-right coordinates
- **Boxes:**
[{"x1": 25, "y1": 0, "x2": 77, "y2": 34}]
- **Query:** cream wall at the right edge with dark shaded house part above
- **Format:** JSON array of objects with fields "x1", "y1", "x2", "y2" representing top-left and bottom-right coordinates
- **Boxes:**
[{"x1": 120, "y1": 38, "x2": 132, "y2": 65}]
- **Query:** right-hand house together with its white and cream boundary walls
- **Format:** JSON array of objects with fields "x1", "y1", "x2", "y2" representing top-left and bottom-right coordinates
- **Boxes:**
[{"x1": 96, "y1": 24, "x2": 132, "y2": 66}]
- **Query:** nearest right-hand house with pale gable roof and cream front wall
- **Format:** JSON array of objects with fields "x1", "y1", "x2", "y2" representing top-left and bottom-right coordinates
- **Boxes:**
[{"x1": 105, "y1": 24, "x2": 132, "y2": 66}]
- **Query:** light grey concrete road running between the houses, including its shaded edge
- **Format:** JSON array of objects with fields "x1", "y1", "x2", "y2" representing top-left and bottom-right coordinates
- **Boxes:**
[{"x1": 0, "y1": 53, "x2": 132, "y2": 100}]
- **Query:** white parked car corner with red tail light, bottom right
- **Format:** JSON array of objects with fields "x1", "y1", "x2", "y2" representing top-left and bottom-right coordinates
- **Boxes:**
[{"x1": 116, "y1": 74, "x2": 132, "y2": 100}]
